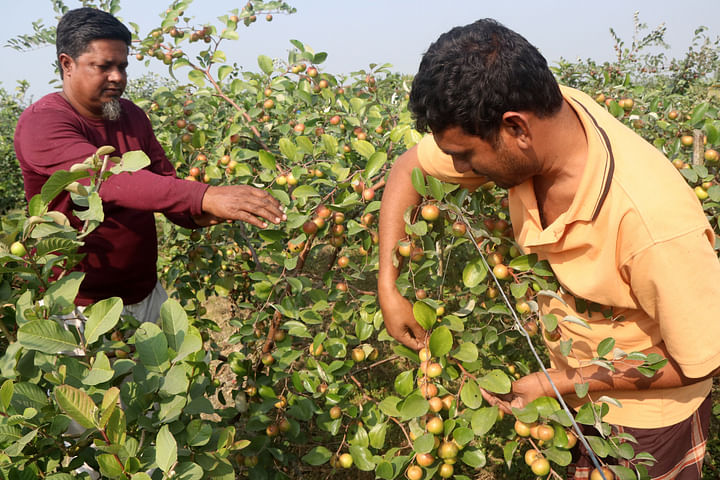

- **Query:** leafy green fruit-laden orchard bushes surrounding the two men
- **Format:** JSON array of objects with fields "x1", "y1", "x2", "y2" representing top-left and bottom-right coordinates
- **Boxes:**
[{"x1": 0, "y1": 1, "x2": 720, "y2": 479}]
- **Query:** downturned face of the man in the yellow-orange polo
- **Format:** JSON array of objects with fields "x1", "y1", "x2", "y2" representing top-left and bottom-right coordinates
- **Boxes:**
[{"x1": 433, "y1": 127, "x2": 537, "y2": 188}]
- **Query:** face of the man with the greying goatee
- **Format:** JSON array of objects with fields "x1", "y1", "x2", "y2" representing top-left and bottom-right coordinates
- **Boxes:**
[{"x1": 60, "y1": 39, "x2": 128, "y2": 118}]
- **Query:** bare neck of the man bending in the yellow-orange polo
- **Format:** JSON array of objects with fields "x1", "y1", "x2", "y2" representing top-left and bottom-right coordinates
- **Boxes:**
[{"x1": 533, "y1": 101, "x2": 588, "y2": 228}]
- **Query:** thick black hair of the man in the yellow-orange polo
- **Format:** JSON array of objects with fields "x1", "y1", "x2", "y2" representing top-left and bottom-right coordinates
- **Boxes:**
[{"x1": 408, "y1": 18, "x2": 563, "y2": 142}]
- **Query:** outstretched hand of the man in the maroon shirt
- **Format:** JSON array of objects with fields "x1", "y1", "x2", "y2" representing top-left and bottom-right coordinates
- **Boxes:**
[{"x1": 193, "y1": 185, "x2": 287, "y2": 228}]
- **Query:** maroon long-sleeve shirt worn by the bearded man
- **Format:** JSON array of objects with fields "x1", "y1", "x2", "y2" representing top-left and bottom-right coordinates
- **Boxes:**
[{"x1": 15, "y1": 93, "x2": 207, "y2": 305}]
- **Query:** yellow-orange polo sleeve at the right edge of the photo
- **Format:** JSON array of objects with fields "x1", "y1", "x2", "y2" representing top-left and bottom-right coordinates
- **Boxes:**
[{"x1": 624, "y1": 228, "x2": 720, "y2": 378}]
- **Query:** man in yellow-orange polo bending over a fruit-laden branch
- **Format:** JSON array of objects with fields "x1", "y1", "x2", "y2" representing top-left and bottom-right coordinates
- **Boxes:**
[{"x1": 378, "y1": 20, "x2": 720, "y2": 479}]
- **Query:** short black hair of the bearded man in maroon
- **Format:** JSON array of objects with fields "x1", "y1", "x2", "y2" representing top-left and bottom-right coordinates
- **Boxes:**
[{"x1": 55, "y1": 7, "x2": 132, "y2": 78}]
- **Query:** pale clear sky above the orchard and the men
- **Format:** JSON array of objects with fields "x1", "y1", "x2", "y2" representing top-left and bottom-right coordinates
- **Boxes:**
[{"x1": 0, "y1": 0, "x2": 720, "y2": 98}]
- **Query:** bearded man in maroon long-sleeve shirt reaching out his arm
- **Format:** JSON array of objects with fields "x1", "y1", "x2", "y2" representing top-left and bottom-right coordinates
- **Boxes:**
[{"x1": 15, "y1": 8, "x2": 285, "y2": 321}]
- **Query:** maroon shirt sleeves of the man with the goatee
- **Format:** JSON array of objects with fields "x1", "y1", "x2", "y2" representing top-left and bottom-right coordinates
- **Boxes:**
[{"x1": 16, "y1": 103, "x2": 207, "y2": 226}]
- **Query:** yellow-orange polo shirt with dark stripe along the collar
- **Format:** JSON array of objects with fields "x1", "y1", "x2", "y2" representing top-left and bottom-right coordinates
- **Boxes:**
[{"x1": 418, "y1": 87, "x2": 720, "y2": 428}]
